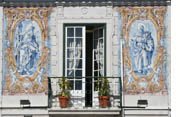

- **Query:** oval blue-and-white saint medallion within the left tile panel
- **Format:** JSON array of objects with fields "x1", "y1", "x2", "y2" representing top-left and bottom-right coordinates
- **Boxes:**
[{"x1": 14, "y1": 19, "x2": 41, "y2": 75}]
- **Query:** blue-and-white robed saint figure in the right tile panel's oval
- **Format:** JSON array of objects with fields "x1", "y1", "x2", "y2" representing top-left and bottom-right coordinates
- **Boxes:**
[{"x1": 130, "y1": 23, "x2": 155, "y2": 75}]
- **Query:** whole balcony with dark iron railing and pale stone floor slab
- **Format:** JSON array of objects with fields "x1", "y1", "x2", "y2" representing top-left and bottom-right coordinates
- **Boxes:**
[{"x1": 49, "y1": 76, "x2": 121, "y2": 114}]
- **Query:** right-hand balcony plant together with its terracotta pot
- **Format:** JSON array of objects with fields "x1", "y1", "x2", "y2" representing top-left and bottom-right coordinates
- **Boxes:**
[{"x1": 99, "y1": 77, "x2": 110, "y2": 108}]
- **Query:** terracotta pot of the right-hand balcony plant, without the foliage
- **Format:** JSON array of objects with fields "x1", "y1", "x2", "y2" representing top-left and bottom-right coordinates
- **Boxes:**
[{"x1": 99, "y1": 96, "x2": 110, "y2": 108}]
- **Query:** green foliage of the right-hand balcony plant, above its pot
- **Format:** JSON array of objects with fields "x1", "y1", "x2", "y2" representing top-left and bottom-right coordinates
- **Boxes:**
[{"x1": 99, "y1": 77, "x2": 110, "y2": 96}]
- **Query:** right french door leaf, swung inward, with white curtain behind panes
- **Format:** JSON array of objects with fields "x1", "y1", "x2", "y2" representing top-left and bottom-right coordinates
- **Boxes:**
[{"x1": 92, "y1": 27, "x2": 105, "y2": 106}]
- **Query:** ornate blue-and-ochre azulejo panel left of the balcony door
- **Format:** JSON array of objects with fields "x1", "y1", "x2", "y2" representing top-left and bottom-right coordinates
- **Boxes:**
[{"x1": 3, "y1": 8, "x2": 50, "y2": 95}]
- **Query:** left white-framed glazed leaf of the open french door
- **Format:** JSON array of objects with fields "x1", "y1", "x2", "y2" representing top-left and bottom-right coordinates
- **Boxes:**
[{"x1": 65, "y1": 26, "x2": 86, "y2": 107}]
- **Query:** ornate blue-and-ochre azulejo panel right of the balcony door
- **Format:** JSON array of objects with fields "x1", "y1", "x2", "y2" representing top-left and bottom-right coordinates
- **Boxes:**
[{"x1": 120, "y1": 7, "x2": 167, "y2": 94}]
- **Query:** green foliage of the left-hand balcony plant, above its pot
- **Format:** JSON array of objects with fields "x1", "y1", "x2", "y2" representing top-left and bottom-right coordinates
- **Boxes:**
[{"x1": 59, "y1": 77, "x2": 71, "y2": 98}]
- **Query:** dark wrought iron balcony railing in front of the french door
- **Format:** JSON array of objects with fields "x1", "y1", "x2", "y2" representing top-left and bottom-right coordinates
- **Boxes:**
[{"x1": 49, "y1": 76, "x2": 122, "y2": 109}]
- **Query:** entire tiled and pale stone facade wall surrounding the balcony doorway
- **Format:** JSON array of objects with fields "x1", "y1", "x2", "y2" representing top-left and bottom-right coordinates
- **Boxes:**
[{"x1": 0, "y1": 6, "x2": 170, "y2": 117}]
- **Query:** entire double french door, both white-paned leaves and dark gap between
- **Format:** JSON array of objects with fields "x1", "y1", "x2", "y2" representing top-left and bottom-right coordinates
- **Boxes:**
[{"x1": 65, "y1": 25, "x2": 105, "y2": 107}]
